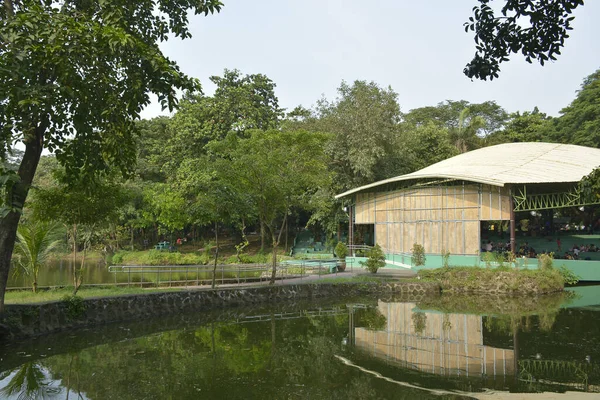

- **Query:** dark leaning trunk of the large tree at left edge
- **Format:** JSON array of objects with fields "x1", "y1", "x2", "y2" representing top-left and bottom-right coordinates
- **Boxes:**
[{"x1": 0, "y1": 125, "x2": 45, "y2": 313}]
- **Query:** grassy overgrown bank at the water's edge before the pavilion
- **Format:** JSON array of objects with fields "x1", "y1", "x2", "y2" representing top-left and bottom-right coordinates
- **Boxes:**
[{"x1": 419, "y1": 267, "x2": 565, "y2": 294}]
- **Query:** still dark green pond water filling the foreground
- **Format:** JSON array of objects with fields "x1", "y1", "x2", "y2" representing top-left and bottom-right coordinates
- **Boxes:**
[{"x1": 0, "y1": 286, "x2": 600, "y2": 400}]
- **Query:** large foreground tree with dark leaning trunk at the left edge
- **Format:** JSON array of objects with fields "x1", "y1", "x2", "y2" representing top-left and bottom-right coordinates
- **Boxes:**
[{"x1": 0, "y1": 0, "x2": 222, "y2": 312}]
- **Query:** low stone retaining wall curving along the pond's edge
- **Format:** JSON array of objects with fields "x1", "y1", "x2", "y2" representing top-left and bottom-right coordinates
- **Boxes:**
[{"x1": 0, "y1": 282, "x2": 440, "y2": 339}]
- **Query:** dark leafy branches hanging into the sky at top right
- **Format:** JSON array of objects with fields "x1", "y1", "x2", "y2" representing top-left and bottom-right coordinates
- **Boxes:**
[{"x1": 464, "y1": 0, "x2": 583, "y2": 80}]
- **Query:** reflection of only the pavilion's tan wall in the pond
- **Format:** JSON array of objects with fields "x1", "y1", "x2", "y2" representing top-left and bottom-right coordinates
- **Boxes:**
[{"x1": 354, "y1": 301, "x2": 515, "y2": 377}]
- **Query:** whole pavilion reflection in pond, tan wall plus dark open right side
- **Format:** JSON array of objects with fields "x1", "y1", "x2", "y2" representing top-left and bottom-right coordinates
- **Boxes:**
[{"x1": 350, "y1": 296, "x2": 600, "y2": 393}]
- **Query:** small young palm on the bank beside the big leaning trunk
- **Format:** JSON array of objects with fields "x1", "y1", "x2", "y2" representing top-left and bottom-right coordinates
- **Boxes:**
[{"x1": 15, "y1": 222, "x2": 60, "y2": 293}]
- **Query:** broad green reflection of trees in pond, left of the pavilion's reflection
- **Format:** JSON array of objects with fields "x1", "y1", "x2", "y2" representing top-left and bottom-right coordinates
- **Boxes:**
[{"x1": 35, "y1": 309, "x2": 420, "y2": 400}]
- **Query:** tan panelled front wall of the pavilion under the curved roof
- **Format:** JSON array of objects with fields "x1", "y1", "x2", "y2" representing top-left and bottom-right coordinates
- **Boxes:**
[{"x1": 355, "y1": 184, "x2": 510, "y2": 255}]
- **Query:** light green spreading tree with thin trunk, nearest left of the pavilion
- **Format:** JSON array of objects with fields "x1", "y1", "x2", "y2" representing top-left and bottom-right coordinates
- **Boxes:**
[{"x1": 211, "y1": 130, "x2": 327, "y2": 283}]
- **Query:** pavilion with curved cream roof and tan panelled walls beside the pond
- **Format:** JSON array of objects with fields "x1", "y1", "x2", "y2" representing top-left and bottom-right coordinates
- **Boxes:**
[{"x1": 336, "y1": 143, "x2": 600, "y2": 280}]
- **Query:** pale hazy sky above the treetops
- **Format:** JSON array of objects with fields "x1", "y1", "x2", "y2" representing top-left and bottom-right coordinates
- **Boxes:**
[{"x1": 142, "y1": 0, "x2": 600, "y2": 118}]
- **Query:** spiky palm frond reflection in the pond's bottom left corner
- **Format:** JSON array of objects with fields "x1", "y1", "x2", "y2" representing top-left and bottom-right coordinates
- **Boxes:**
[{"x1": 0, "y1": 362, "x2": 60, "y2": 400}]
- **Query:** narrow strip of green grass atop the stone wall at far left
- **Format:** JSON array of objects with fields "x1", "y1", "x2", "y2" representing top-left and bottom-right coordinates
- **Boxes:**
[{"x1": 4, "y1": 286, "x2": 182, "y2": 304}]
